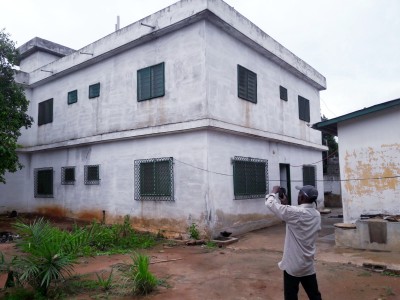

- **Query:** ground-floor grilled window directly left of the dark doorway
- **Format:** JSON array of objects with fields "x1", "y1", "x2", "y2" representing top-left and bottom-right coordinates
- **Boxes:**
[{"x1": 232, "y1": 156, "x2": 268, "y2": 199}]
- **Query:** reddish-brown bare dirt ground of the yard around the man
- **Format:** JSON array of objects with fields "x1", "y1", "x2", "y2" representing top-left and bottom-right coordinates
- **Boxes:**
[{"x1": 0, "y1": 211, "x2": 400, "y2": 300}]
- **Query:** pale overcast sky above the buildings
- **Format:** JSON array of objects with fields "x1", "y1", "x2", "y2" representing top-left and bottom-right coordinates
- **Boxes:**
[{"x1": 0, "y1": 0, "x2": 400, "y2": 118}]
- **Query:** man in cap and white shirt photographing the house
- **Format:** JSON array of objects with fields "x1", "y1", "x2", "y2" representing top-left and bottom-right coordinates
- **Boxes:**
[{"x1": 265, "y1": 185, "x2": 321, "y2": 300}]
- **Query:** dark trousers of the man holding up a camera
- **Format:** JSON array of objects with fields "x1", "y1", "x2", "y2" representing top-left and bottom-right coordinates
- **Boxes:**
[{"x1": 283, "y1": 271, "x2": 322, "y2": 300}]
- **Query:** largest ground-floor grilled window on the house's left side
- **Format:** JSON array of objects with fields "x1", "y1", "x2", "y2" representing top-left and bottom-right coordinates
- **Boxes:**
[{"x1": 135, "y1": 157, "x2": 174, "y2": 201}]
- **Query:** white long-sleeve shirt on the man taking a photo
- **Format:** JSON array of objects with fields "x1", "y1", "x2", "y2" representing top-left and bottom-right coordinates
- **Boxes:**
[{"x1": 265, "y1": 194, "x2": 321, "y2": 277}]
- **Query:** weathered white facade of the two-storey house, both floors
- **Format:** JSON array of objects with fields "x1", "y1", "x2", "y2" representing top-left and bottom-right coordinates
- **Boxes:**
[{"x1": 0, "y1": 0, "x2": 326, "y2": 236}]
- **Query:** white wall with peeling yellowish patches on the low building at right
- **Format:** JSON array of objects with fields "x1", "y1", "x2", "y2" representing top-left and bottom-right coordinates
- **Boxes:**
[{"x1": 338, "y1": 108, "x2": 400, "y2": 223}]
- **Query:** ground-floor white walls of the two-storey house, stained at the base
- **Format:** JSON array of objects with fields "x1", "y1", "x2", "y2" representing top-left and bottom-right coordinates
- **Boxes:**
[{"x1": 0, "y1": 130, "x2": 323, "y2": 235}]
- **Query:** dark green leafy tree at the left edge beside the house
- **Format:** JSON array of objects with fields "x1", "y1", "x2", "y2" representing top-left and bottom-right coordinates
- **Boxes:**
[{"x1": 0, "y1": 29, "x2": 33, "y2": 183}]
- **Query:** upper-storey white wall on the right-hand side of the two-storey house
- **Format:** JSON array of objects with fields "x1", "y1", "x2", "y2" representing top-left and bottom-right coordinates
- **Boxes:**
[{"x1": 206, "y1": 23, "x2": 321, "y2": 144}]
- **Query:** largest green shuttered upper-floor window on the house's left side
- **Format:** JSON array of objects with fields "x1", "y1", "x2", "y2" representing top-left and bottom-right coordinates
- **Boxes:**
[{"x1": 137, "y1": 63, "x2": 165, "y2": 101}]
